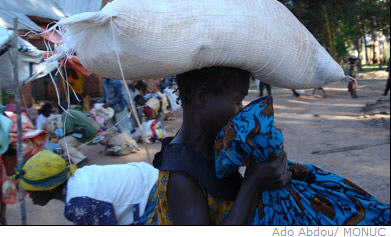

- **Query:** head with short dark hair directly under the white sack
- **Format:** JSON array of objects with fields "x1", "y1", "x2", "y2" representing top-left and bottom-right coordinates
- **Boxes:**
[{"x1": 176, "y1": 67, "x2": 251, "y2": 137}]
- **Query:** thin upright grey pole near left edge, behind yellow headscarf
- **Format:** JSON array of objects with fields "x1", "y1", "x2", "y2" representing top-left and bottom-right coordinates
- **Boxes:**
[{"x1": 11, "y1": 18, "x2": 26, "y2": 225}]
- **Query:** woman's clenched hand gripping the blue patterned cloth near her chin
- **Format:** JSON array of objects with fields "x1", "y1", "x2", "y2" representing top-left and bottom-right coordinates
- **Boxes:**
[{"x1": 244, "y1": 151, "x2": 292, "y2": 189}]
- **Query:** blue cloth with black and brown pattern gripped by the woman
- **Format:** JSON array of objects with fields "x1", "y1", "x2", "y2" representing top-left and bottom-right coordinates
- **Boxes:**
[{"x1": 215, "y1": 97, "x2": 390, "y2": 225}]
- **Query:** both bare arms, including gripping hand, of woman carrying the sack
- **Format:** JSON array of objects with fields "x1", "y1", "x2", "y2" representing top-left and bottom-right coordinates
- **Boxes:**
[{"x1": 167, "y1": 152, "x2": 290, "y2": 225}]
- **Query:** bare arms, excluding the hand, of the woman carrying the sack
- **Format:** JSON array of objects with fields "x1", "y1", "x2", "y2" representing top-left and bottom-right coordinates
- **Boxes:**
[{"x1": 167, "y1": 172, "x2": 261, "y2": 225}]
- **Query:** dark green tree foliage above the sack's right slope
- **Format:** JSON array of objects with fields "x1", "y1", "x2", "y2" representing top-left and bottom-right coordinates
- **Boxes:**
[{"x1": 280, "y1": 0, "x2": 390, "y2": 61}]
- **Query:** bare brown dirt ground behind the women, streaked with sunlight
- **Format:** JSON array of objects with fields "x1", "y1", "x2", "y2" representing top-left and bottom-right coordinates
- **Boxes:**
[{"x1": 7, "y1": 71, "x2": 390, "y2": 225}]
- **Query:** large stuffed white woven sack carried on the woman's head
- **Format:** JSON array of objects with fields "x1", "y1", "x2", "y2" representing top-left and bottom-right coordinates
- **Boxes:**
[{"x1": 49, "y1": 0, "x2": 345, "y2": 88}]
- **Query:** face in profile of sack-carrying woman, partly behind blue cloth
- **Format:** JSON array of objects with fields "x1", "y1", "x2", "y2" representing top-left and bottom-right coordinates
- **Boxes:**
[{"x1": 200, "y1": 80, "x2": 249, "y2": 139}]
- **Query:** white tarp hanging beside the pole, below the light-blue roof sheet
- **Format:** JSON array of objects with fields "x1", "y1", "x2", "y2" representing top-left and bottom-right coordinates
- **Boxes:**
[{"x1": 0, "y1": 26, "x2": 58, "y2": 89}]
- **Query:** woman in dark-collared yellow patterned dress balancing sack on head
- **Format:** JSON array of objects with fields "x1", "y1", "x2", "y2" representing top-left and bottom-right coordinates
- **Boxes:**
[{"x1": 154, "y1": 67, "x2": 290, "y2": 225}]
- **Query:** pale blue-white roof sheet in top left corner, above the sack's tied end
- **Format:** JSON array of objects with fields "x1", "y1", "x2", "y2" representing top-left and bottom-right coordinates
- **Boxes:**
[{"x1": 0, "y1": 0, "x2": 102, "y2": 32}]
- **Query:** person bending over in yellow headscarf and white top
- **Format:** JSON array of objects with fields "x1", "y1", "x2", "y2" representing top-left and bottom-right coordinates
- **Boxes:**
[{"x1": 15, "y1": 150, "x2": 158, "y2": 225}]
